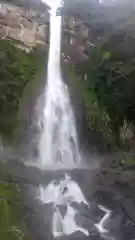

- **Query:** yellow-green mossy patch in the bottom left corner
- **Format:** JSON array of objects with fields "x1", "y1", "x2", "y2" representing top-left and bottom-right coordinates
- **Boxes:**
[{"x1": 0, "y1": 182, "x2": 30, "y2": 240}]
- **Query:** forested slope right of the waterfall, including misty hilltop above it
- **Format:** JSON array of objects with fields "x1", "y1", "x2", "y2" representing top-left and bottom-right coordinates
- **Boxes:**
[{"x1": 63, "y1": 0, "x2": 135, "y2": 148}]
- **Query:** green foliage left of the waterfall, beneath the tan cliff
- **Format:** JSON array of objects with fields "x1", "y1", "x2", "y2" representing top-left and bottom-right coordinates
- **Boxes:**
[{"x1": 0, "y1": 40, "x2": 39, "y2": 140}]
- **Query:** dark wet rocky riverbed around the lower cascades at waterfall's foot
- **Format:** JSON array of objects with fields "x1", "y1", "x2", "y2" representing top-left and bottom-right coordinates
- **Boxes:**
[{"x1": 0, "y1": 159, "x2": 135, "y2": 240}]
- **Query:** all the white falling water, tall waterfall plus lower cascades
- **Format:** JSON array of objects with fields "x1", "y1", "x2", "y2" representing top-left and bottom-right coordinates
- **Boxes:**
[{"x1": 39, "y1": 1, "x2": 111, "y2": 237}]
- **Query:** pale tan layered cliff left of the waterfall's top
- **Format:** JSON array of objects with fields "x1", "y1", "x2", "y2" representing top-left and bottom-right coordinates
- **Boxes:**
[{"x1": 0, "y1": 2, "x2": 49, "y2": 48}]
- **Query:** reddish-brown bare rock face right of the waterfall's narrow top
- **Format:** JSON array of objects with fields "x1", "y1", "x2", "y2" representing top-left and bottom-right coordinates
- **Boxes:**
[{"x1": 62, "y1": 16, "x2": 94, "y2": 61}]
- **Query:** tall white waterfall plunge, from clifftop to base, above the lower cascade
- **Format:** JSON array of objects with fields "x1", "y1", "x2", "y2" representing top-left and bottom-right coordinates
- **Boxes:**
[{"x1": 39, "y1": 8, "x2": 80, "y2": 167}]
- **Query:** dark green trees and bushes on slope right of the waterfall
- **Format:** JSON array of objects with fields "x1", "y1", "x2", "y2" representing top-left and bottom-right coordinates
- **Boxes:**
[{"x1": 65, "y1": 29, "x2": 135, "y2": 145}]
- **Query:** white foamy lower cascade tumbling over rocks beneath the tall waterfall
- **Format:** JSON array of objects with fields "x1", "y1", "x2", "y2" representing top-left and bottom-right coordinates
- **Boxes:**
[{"x1": 40, "y1": 174, "x2": 89, "y2": 237}]
